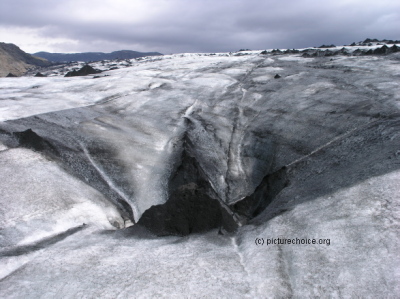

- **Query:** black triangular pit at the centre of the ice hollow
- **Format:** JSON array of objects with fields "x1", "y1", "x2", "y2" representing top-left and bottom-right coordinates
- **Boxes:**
[{"x1": 138, "y1": 138, "x2": 237, "y2": 235}]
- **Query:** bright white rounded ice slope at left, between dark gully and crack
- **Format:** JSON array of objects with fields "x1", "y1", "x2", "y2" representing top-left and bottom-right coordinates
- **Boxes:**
[{"x1": 0, "y1": 149, "x2": 124, "y2": 248}]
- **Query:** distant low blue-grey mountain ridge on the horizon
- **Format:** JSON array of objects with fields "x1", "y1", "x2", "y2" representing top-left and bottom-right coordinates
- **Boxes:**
[{"x1": 33, "y1": 50, "x2": 163, "y2": 62}]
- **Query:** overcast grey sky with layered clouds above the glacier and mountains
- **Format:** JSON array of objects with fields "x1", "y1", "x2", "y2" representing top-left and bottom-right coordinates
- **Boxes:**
[{"x1": 0, "y1": 0, "x2": 400, "y2": 54}]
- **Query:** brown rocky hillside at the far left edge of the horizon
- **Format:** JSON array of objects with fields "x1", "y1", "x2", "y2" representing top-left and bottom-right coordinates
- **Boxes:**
[{"x1": 0, "y1": 43, "x2": 51, "y2": 77}]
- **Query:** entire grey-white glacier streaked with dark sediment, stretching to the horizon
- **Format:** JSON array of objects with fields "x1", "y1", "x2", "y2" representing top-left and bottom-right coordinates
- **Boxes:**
[{"x1": 0, "y1": 47, "x2": 400, "y2": 298}]
